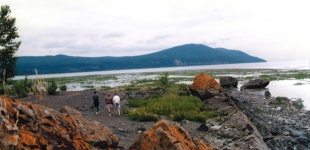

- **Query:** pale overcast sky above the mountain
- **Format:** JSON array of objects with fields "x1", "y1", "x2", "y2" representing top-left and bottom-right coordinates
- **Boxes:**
[{"x1": 0, "y1": 0, "x2": 310, "y2": 61}]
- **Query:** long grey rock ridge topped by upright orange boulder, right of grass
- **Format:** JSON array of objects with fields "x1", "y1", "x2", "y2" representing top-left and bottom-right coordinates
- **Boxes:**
[{"x1": 190, "y1": 73, "x2": 269, "y2": 150}]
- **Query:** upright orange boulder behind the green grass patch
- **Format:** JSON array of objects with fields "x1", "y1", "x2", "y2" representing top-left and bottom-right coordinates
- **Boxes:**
[{"x1": 189, "y1": 72, "x2": 223, "y2": 100}]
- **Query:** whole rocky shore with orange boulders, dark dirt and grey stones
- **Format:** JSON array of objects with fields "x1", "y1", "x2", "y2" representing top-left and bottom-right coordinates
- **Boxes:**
[{"x1": 0, "y1": 73, "x2": 310, "y2": 150}]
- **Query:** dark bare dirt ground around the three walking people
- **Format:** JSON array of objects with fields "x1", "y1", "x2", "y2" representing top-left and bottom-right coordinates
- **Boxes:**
[{"x1": 22, "y1": 91, "x2": 203, "y2": 149}]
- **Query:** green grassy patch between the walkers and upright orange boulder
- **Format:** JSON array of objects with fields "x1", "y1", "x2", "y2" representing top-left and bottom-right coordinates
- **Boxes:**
[{"x1": 128, "y1": 94, "x2": 218, "y2": 122}]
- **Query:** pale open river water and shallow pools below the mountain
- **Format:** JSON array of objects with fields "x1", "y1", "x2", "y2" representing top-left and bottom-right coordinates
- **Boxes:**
[{"x1": 14, "y1": 60, "x2": 310, "y2": 110}]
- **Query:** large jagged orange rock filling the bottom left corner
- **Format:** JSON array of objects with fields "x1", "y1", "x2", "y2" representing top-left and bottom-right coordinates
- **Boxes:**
[{"x1": 0, "y1": 96, "x2": 118, "y2": 149}]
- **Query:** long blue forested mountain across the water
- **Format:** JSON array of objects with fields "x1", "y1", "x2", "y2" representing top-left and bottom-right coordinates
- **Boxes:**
[{"x1": 17, "y1": 44, "x2": 266, "y2": 75}]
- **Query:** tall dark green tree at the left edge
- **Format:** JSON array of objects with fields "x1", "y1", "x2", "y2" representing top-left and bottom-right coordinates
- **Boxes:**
[{"x1": 0, "y1": 5, "x2": 21, "y2": 81}]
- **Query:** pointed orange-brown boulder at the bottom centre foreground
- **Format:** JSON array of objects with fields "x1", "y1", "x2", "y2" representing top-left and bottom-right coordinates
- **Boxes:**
[{"x1": 129, "y1": 120, "x2": 213, "y2": 150}]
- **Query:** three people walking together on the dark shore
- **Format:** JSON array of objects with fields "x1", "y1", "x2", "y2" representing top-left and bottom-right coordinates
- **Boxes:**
[{"x1": 93, "y1": 90, "x2": 121, "y2": 116}]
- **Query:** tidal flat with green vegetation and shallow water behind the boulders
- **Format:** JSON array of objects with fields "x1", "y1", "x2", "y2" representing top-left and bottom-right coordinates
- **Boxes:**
[{"x1": 40, "y1": 69, "x2": 310, "y2": 110}]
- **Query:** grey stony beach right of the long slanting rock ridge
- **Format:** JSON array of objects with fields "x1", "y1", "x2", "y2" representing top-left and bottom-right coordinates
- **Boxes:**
[{"x1": 227, "y1": 90, "x2": 310, "y2": 150}]
